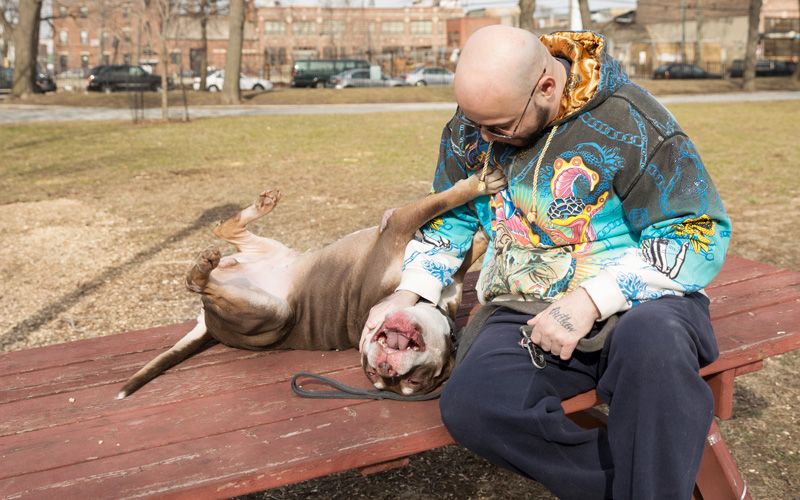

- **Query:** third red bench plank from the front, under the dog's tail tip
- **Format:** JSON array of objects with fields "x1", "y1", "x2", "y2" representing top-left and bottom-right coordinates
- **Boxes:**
[{"x1": 0, "y1": 350, "x2": 360, "y2": 436}]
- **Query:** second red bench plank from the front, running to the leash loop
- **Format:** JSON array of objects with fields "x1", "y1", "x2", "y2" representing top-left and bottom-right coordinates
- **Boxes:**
[{"x1": 0, "y1": 367, "x2": 376, "y2": 479}]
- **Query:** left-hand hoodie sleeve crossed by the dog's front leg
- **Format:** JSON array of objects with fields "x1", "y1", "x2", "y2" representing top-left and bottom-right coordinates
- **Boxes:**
[{"x1": 397, "y1": 114, "x2": 479, "y2": 304}]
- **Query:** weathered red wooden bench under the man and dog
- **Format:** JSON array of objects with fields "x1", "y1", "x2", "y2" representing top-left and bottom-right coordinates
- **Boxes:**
[{"x1": 0, "y1": 258, "x2": 800, "y2": 499}]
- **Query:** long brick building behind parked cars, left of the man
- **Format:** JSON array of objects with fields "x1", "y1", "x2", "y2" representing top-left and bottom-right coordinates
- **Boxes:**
[{"x1": 52, "y1": 0, "x2": 463, "y2": 81}]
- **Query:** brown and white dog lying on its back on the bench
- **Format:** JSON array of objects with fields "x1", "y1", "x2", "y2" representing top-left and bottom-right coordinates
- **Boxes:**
[{"x1": 117, "y1": 169, "x2": 506, "y2": 399}]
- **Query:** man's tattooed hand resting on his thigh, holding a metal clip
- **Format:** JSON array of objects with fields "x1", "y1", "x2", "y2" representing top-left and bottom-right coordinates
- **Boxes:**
[{"x1": 528, "y1": 288, "x2": 600, "y2": 360}]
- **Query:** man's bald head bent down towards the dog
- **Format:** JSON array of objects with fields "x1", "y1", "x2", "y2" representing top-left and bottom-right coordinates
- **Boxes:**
[{"x1": 454, "y1": 25, "x2": 566, "y2": 146}]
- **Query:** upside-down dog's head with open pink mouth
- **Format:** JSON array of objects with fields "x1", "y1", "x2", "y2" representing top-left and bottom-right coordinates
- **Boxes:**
[{"x1": 361, "y1": 303, "x2": 453, "y2": 396}]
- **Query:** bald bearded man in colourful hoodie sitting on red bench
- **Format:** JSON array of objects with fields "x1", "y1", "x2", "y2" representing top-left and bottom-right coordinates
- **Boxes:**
[{"x1": 365, "y1": 26, "x2": 730, "y2": 499}]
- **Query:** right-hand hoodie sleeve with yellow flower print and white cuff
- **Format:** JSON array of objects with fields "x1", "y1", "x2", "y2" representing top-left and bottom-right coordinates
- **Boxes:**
[{"x1": 581, "y1": 134, "x2": 731, "y2": 319}]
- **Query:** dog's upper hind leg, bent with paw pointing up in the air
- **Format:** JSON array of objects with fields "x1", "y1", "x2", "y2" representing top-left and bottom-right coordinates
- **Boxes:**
[{"x1": 214, "y1": 189, "x2": 287, "y2": 252}]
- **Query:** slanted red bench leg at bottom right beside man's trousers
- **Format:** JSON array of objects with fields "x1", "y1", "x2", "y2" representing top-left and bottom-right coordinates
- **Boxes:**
[{"x1": 694, "y1": 420, "x2": 751, "y2": 500}]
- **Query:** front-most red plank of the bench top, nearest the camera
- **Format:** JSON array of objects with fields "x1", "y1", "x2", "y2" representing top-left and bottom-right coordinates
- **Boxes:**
[{"x1": 0, "y1": 396, "x2": 452, "y2": 498}]
